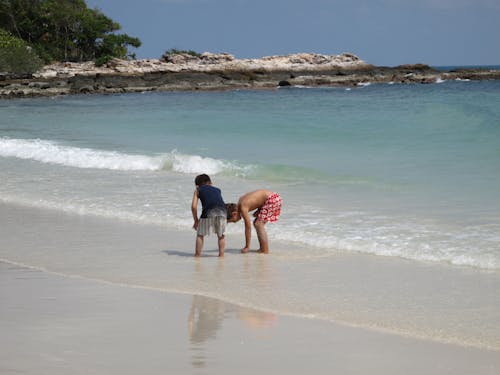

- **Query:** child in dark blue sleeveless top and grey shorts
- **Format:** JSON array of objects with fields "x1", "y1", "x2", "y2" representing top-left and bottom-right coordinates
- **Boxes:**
[{"x1": 191, "y1": 174, "x2": 227, "y2": 257}]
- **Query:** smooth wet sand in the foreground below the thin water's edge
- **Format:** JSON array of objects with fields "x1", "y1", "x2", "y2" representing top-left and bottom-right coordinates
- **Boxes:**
[{"x1": 0, "y1": 263, "x2": 500, "y2": 375}]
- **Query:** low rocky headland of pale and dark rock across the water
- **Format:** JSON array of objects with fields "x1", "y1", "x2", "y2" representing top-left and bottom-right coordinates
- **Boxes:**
[{"x1": 0, "y1": 53, "x2": 500, "y2": 99}]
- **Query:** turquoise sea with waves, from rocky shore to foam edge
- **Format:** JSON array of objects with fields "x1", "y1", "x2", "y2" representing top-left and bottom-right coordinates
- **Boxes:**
[{"x1": 0, "y1": 81, "x2": 500, "y2": 269}]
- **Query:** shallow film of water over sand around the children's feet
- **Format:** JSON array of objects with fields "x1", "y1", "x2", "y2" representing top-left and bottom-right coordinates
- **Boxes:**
[{"x1": 0, "y1": 203, "x2": 500, "y2": 353}]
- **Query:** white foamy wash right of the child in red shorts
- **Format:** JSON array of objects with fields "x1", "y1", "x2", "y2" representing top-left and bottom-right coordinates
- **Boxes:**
[{"x1": 269, "y1": 218, "x2": 500, "y2": 270}]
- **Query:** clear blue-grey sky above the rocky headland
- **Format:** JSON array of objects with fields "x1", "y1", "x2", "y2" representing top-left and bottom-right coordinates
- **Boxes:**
[{"x1": 86, "y1": 0, "x2": 500, "y2": 66}]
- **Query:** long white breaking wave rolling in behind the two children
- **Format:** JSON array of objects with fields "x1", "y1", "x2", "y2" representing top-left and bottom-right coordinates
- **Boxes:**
[{"x1": 0, "y1": 137, "x2": 338, "y2": 182}]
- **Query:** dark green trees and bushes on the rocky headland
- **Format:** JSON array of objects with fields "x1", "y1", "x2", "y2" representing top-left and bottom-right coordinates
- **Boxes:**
[{"x1": 0, "y1": 0, "x2": 141, "y2": 73}]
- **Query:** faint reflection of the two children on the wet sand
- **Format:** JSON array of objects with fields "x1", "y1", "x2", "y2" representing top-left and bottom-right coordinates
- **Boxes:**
[{"x1": 188, "y1": 295, "x2": 276, "y2": 368}]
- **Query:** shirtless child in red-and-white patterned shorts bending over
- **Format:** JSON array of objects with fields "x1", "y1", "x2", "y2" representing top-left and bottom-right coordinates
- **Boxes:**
[{"x1": 226, "y1": 189, "x2": 281, "y2": 254}]
